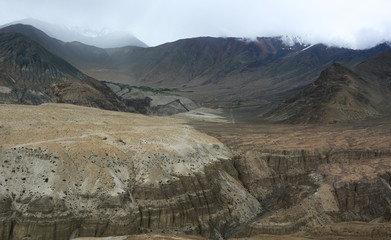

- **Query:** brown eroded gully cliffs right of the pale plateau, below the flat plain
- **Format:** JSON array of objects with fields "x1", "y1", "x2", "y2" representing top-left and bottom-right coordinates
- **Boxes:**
[{"x1": 234, "y1": 151, "x2": 391, "y2": 236}]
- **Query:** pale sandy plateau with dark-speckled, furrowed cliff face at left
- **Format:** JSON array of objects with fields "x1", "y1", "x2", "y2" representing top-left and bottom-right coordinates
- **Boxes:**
[{"x1": 0, "y1": 104, "x2": 261, "y2": 239}]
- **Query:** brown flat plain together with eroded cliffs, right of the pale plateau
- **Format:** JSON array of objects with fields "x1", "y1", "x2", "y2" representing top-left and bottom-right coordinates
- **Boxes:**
[{"x1": 193, "y1": 114, "x2": 391, "y2": 239}]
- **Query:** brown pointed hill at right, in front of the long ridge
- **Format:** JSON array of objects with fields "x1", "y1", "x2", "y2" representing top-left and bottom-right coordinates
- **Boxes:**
[{"x1": 264, "y1": 51, "x2": 391, "y2": 123}]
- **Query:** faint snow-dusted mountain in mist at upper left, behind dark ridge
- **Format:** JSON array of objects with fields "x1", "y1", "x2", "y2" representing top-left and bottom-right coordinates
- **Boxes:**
[{"x1": 0, "y1": 18, "x2": 148, "y2": 48}]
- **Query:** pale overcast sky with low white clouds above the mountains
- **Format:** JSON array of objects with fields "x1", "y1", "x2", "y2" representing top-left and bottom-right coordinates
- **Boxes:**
[{"x1": 0, "y1": 0, "x2": 391, "y2": 48}]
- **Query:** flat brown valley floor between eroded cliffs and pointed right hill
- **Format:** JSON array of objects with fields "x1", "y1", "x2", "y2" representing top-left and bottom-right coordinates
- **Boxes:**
[{"x1": 187, "y1": 109, "x2": 391, "y2": 151}]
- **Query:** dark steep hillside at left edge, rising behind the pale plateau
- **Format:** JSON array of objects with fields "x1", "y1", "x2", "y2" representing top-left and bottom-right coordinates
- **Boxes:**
[{"x1": 0, "y1": 33, "x2": 128, "y2": 111}]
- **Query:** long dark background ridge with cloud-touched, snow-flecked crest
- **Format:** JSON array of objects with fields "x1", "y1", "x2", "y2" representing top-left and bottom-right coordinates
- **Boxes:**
[{"x1": 0, "y1": 24, "x2": 391, "y2": 108}]
